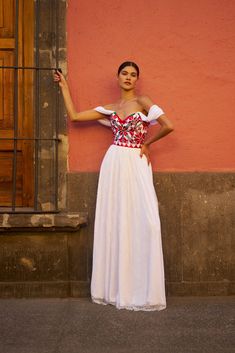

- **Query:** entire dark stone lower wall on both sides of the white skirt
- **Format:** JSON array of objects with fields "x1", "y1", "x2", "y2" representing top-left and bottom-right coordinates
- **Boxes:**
[{"x1": 0, "y1": 172, "x2": 235, "y2": 298}]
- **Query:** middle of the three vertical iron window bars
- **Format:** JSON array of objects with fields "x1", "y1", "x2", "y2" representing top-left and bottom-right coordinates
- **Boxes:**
[{"x1": 34, "y1": 0, "x2": 40, "y2": 211}]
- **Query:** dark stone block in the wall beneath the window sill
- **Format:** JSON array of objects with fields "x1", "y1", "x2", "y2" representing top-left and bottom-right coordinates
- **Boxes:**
[{"x1": 0, "y1": 234, "x2": 68, "y2": 282}]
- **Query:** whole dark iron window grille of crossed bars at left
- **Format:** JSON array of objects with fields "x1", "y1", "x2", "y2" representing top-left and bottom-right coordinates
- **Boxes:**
[{"x1": 0, "y1": 0, "x2": 61, "y2": 214}]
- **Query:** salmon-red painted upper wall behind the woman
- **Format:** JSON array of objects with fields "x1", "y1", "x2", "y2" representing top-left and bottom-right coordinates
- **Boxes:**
[{"x1": 67, "y1": 0, "x2": 235, "y2": 171}]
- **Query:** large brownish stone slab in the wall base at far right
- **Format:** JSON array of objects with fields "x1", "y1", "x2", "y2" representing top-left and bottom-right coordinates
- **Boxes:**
[{"x1": 181, "y1": 173, "x2": 235, "y2": 282}]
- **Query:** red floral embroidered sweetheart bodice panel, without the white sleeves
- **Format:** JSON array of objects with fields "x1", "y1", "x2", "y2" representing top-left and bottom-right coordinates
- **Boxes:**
[{"x1": 110, "y1": 112, "x2": 149, "y2": 148}]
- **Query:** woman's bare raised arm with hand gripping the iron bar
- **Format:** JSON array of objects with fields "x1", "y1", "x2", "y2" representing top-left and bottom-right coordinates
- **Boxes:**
[{"x1": 54, "y1": 71, "x2": 104, "y2": 121}]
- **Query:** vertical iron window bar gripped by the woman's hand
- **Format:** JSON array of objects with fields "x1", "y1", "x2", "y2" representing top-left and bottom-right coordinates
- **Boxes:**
[{"x1": 54, "y1": 0, "x2": 60, "y2": 210}]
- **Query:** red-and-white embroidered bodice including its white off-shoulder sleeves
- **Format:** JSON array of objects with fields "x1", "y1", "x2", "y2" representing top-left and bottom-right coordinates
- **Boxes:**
[{"x1": 95, "y1": 105, "x2": 164, "y2": 148}]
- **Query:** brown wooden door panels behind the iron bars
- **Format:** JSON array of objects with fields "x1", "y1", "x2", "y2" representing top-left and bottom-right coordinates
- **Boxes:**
[{"x1": 0, "y1": 0, "x2": 34, "y2": 207}]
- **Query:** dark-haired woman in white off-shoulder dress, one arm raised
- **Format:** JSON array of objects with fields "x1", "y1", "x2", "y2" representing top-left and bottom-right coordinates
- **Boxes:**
[{"x1": 55, "y1": 62, "x2": 173, "y2": 311}]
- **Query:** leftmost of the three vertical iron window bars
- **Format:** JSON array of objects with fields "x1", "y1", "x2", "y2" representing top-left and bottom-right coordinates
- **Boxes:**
[{"x1": 12, "y1": 0, "x2": 19, "y2": 211}]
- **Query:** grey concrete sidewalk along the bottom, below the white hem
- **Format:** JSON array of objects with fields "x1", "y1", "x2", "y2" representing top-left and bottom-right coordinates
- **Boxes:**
[{"x1": 0, "y1": 297, "x2": 235, "y2": 353}]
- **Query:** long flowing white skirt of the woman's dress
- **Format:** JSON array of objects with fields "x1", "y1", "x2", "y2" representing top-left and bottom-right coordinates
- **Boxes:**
[{"x1": 91, "y1": 145, "x2": 166, "y2": 311}]
